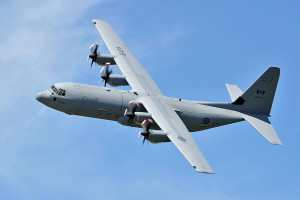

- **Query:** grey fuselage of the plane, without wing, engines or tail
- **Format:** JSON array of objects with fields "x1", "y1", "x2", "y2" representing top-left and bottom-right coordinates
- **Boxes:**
[{"x1": 36, "y1": 82, "x2": 244, "y2": 132}]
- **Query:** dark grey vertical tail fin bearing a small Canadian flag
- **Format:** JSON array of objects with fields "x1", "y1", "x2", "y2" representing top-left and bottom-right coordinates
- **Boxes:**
[{"x1": 232, "y1": 67, "x2": 280, "y2": 115}]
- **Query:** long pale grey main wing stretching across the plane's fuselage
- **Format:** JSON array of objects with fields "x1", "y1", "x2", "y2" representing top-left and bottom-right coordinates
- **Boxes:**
[{"x1": 93, "y1": 20, "x2": 214, "y2": 173}]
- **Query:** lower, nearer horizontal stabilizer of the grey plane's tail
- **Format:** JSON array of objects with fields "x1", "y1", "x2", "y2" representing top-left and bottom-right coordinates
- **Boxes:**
[{"x1": 243, "y1": 114, "x2": 281, "y2": 145}]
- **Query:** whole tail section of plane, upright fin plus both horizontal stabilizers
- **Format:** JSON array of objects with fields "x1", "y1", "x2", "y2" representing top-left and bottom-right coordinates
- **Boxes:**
[{"x1": 201, "y1": 67, "x2": 281, "y2": 145}]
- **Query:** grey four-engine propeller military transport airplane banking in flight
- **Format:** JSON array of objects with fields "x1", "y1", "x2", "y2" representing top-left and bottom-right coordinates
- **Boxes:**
[{"x1": 36, "y1": 19, "x2": 281, "y2": 174}]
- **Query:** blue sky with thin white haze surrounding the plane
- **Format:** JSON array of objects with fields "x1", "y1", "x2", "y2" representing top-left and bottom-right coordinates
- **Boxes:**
[{"x1": 0, "y1": 0, "x2": 300, "y2": 200}]
